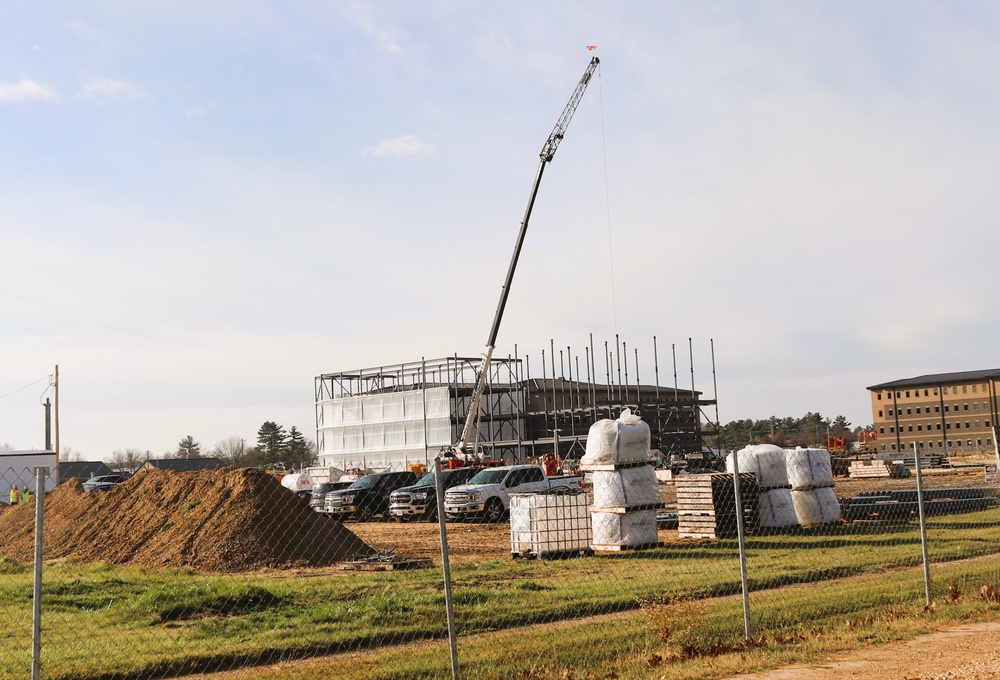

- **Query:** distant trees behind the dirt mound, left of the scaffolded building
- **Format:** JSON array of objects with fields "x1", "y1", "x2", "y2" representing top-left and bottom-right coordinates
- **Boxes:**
[{"x1": 104, "y1": 420, "x2": 316, "y2": 472}]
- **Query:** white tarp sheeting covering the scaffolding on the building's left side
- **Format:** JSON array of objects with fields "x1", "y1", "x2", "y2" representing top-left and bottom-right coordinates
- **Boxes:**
[{"x1": 316, "y1": 387, "x2": 453, "y2": 469}]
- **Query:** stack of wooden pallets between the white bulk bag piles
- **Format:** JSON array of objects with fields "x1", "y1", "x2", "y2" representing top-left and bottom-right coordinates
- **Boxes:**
[{"x1": 675, "y1": 472, "x2": 759, "y2": 539}]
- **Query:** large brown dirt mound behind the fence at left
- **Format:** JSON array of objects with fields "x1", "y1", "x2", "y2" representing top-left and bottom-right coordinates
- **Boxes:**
[{"x1": 0, "y1": 468, "x2": 374, "y2": 572}]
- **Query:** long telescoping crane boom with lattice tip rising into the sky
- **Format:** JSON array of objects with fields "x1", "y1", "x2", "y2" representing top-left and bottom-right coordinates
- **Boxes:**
[{"x1": 453, "y1": 57, "x2": 601, "y2": 454}]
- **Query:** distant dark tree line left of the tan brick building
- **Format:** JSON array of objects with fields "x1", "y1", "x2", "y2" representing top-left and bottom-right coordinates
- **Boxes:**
[{"x1": 707, "y1": 411, "x2": 863, "y2": 450}]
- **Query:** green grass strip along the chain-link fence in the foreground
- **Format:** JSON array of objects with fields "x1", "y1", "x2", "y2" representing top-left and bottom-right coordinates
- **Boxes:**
[{"x1": 0, "y1": 511, "x2": 1000, "y2": 680}]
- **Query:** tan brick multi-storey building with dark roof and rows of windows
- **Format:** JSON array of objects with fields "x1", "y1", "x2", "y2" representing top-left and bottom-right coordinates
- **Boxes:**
[{"x1": 868, "y1": 369, "x2": 1000, "y2": 453}]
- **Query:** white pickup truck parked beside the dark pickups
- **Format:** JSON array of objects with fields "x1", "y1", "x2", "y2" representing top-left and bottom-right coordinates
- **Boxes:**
[{"x1": 444, "y1": 465, "x2": 582, "y2": 522}]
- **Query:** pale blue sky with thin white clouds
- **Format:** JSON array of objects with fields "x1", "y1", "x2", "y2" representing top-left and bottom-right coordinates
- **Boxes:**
[{"x1": 0, "y1": 0, "x2": 1000, "y2": 460}]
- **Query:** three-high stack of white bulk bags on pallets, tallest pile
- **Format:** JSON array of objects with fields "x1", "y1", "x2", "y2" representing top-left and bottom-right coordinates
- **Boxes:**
[{"x1": 580, "y1": 409, "x2": 663, "y2": 552}]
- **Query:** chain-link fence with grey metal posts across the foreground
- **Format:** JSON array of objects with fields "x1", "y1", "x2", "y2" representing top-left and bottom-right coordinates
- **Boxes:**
[{"x1": 0, "y1": 430, "x2": 1000, "y2": 680}]
